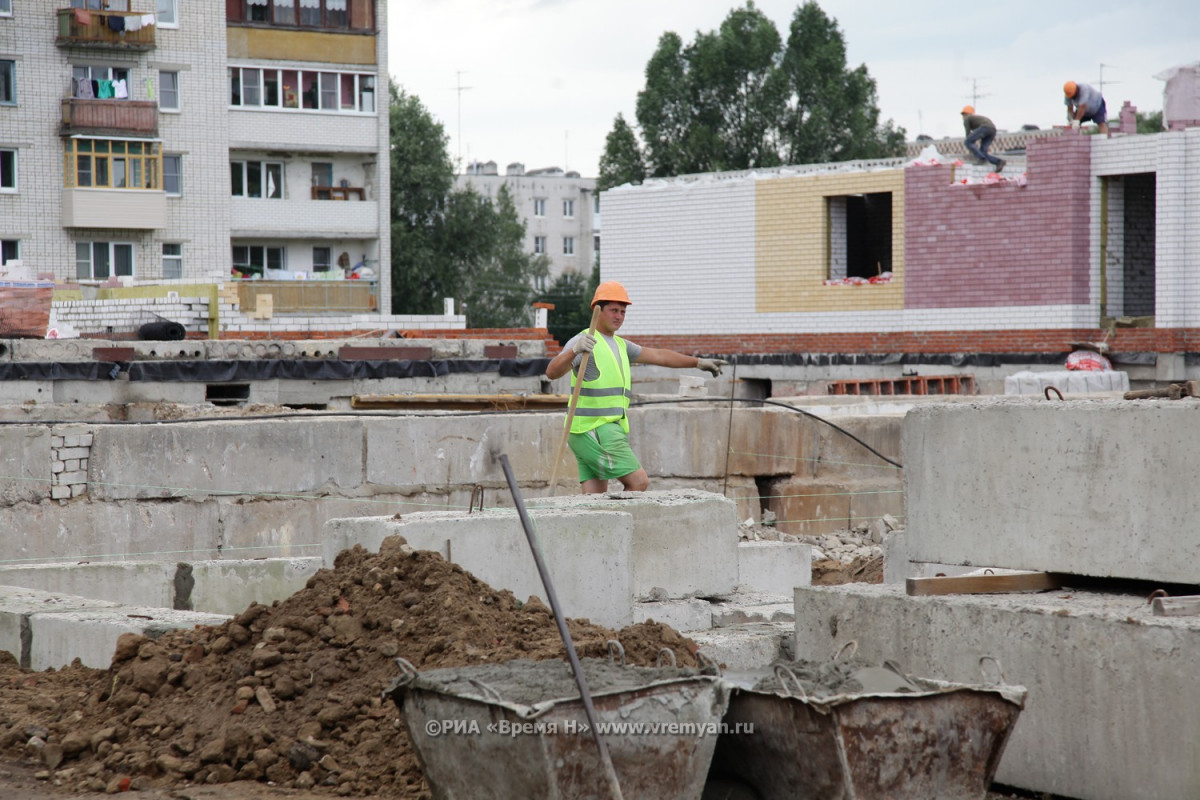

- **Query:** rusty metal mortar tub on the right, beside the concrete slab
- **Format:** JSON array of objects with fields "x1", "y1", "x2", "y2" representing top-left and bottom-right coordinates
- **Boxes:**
[{"x1": 712, "y1": 667, "x2": 1026, "y2": 800}]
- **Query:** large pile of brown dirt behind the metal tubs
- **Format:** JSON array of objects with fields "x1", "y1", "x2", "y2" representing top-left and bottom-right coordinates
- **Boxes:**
[{"x1": 0, "y1": 537, "x2": 696, "y2": 798}]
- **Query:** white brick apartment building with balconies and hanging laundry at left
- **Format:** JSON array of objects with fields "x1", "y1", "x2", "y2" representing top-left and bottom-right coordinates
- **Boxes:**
[{"x1": 0, "y1": 0, "x2": 390, "y2": 312}]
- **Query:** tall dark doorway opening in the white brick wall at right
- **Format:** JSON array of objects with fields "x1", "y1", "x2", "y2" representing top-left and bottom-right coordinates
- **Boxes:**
[{"x1": 1100, "y1": 173, "x2": 1157, "y2": 320}]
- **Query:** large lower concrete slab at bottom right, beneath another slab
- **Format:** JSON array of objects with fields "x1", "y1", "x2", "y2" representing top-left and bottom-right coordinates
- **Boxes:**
[{"x1": 796, "y1": 584, "x2": 1200, "y2": 800}]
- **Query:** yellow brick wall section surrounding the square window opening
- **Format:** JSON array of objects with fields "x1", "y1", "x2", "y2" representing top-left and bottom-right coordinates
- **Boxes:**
[{"x1": 755, "y1": 169, "x2": 904, "y2": 313}]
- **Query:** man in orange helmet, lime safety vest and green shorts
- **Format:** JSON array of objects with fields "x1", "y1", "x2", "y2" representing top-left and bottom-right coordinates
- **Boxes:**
[{"x1": 546, "y1": 281, "x2": 726, "y2": 494}]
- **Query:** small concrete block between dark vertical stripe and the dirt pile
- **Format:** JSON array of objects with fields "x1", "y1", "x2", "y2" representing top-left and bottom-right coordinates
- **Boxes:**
[{"x1": 186, "y1": 555, "x2": 323, "y2": 616}]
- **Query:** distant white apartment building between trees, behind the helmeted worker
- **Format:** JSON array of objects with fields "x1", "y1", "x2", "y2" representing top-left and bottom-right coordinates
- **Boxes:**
[{"x1": 455, "y1": 161, "x2": 600, "y2": 289}]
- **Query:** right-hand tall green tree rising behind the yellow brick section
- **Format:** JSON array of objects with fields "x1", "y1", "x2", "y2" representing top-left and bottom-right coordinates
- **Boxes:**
[{"x1": 781, "y1": 0, "x2": 905, "y2": 164}]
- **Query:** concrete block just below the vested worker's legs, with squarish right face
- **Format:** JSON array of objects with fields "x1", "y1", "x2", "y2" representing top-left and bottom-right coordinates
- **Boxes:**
[{"x1": 537, "y1": 489, "x2": 738, "y2": 600}]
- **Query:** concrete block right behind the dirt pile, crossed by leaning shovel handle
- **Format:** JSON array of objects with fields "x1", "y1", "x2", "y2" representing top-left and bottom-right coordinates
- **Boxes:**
[{"x1": 322, "y1": 509, "x2": 634, "y2": 627}]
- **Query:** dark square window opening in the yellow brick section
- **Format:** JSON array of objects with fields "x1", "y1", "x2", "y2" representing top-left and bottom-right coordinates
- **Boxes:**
[{"x1": 826, "y1": 192, "x2": 892, "y2": 278}]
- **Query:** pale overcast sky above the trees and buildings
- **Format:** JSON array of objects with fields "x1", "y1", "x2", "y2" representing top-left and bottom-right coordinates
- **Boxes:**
[{"x1": 388, "y1": 0, "x2": 1200, "y2": 178}]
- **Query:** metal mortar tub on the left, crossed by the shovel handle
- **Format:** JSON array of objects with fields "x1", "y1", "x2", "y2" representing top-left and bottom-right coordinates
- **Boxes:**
[{"x1": 386, "y1": 658, "x2": 730, "y2": 800}]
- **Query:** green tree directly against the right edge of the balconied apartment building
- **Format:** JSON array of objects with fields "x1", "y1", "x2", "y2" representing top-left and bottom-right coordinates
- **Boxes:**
[{"x1": 388, "y1": 83, "x2": 454, "y2": 314}]
